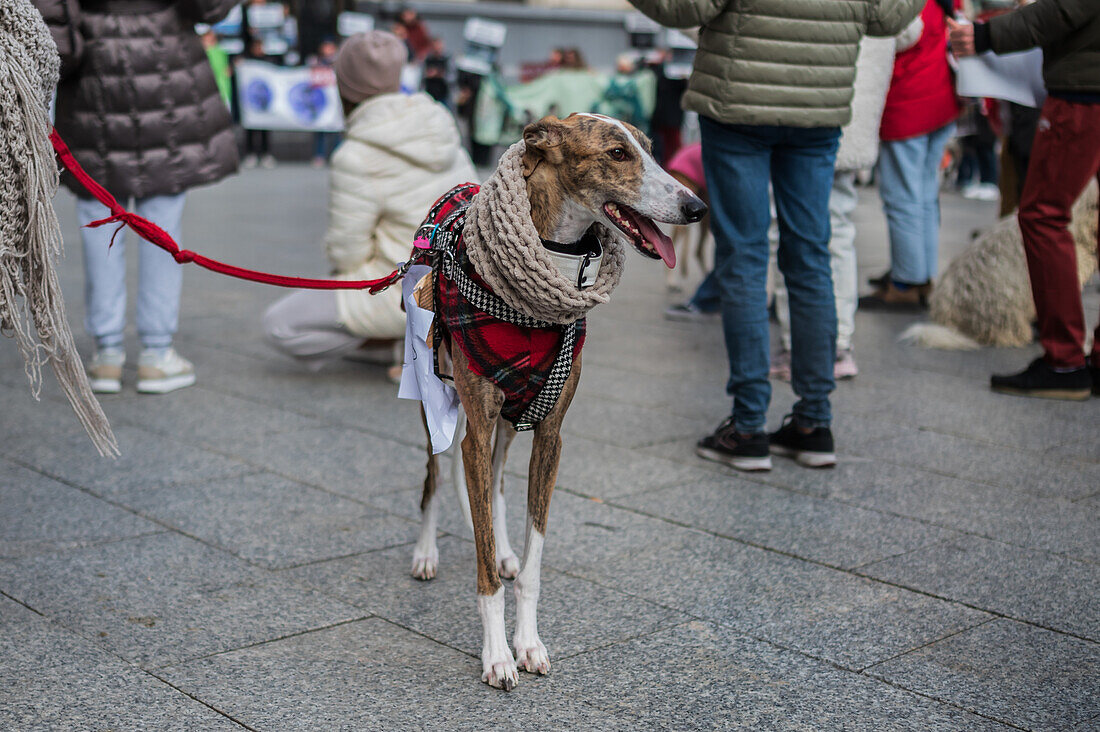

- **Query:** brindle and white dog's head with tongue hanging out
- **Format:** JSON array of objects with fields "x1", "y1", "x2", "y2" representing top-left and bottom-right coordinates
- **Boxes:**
[{"x1": 524, "y1": 113, "x2": 706, "y2": 267}]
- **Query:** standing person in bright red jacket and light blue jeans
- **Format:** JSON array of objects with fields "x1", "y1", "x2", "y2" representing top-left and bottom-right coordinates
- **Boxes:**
[{"x1": 859, "y1": 0, "x2": 959, "y2": 310}]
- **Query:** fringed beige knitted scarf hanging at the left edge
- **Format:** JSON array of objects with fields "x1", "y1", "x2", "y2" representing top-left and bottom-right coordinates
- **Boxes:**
[{"x1": 0, "y1": 0, "x2": 119, "y2": 455}]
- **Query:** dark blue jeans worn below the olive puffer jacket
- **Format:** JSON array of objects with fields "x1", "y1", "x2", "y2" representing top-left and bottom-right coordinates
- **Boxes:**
[{"x1": 700, "y1": 118, "x2": 840, "y2": 433}]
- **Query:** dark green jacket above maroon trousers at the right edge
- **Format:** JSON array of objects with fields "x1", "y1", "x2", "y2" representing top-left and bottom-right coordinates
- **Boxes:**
[{"x1": 975, "y1": 0, "x2": 1100, "y2": 94}]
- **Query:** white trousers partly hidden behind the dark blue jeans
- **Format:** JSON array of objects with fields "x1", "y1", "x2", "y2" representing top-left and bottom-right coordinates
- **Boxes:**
[{"x1": 776, "y1": 171, "x2": 859, "y2": 351}]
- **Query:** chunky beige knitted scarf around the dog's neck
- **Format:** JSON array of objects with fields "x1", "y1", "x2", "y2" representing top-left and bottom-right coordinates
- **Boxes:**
[{"x1": 462, "y1": 141, "x2": 626, "y2": 324}]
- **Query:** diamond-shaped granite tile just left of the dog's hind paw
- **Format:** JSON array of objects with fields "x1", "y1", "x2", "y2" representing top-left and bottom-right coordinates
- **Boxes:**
[{"x1": 118, "y1": 472, "x2": 416, "y2": 569}]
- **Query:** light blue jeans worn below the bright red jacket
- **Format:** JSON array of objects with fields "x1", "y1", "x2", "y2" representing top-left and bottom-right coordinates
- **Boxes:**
[{"x1": 879, "y1": 122, "x2": 955, "y2": 285}]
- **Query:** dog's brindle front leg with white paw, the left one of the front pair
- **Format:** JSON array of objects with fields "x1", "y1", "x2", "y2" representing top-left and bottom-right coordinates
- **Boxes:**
[{"x1": 451, "y1": 349, "x2": 519, "y2": 691}]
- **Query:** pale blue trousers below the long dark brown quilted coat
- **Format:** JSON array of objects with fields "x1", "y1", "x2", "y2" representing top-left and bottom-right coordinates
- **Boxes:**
[{"x1": 76, "y1": 194, "x2": 185, "y2": 349}]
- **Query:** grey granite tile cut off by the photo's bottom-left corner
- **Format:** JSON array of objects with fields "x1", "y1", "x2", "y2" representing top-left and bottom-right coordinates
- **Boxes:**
[{"x1": 0, "y1": 653, "x2": 245, "y2": 732}]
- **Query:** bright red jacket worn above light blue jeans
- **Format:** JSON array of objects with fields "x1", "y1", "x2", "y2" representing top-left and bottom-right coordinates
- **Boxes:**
[{"x1": 879, "y1": 0, "x2": 959, "y2": 140}]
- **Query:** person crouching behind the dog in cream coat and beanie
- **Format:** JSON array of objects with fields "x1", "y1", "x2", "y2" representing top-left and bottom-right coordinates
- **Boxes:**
[{"x1": 263, "y1": 31, "x2": 475, "y2": 376}]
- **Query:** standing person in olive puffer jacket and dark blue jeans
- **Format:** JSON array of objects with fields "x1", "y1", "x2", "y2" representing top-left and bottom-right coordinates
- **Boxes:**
[{"x1": 630, "y1": 0, "x2": 923, "y2": 470}]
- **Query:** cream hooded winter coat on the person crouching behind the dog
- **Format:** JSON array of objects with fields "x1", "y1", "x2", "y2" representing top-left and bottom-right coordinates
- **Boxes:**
[{"x1": 325, "y1": 94, "x2": 476, "y2": 338}]
